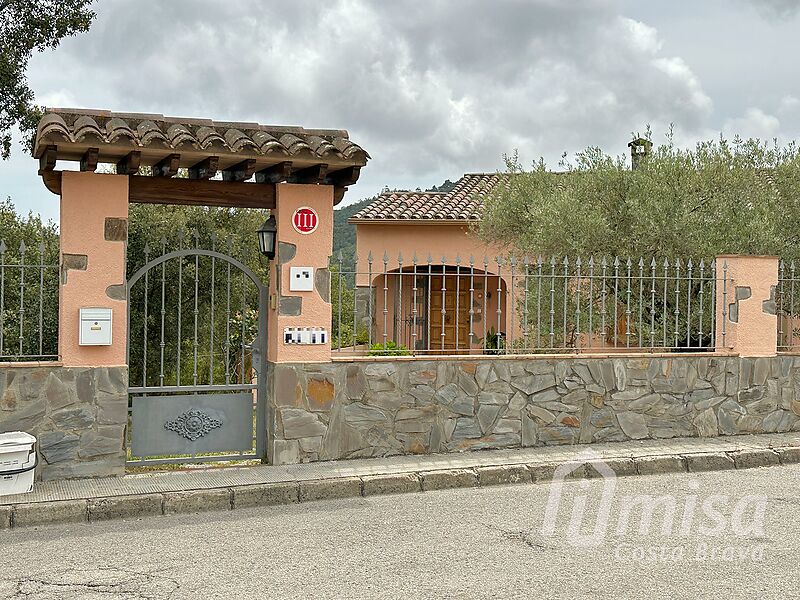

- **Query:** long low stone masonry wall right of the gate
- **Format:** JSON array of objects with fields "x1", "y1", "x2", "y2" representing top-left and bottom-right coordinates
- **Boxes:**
[{"x1": 270, "y1": 355, "x2": 800, "y2": 464}]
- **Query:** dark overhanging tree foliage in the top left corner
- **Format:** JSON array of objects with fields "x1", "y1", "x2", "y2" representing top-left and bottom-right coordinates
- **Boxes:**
[{"x1": 0, "y1": 0, "x2": 95, "y2": 158}]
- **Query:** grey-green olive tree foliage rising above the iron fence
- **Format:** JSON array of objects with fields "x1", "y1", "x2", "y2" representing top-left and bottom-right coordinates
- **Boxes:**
[{"x1": 479, "y1": 134, "x2": 800, "y2": 258}]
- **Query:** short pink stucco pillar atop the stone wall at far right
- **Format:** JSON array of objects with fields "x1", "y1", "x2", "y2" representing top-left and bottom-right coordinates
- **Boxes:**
[{"x1": 715, "y1": 255, "x2": 778, "y2": 357}]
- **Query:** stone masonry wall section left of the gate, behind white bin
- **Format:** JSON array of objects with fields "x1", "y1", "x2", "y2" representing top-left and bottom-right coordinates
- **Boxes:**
[{"x1": 0, "y1": 366, "x2": 128, "y2": 480}]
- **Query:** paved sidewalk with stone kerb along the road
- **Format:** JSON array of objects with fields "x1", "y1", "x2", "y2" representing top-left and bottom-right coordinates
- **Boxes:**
[{"x1": 0, "y1": 432, "x2": 800, "y2": 529}]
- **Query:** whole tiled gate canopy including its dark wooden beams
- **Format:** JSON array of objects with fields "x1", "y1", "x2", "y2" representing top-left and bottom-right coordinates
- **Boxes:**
[{"x1": 33, "y1": 108, "x2": 370, "y2": 208}]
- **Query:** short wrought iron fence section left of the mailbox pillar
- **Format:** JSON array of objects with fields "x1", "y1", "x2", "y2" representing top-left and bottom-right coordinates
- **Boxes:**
[{"x1": 0, "y1": 239, "x2": 58, "y2": 362}]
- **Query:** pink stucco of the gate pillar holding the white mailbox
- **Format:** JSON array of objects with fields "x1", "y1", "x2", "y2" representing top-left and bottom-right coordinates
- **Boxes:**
[{"x1": 59, "y1": 171, "x2": 128, "y2": 367}]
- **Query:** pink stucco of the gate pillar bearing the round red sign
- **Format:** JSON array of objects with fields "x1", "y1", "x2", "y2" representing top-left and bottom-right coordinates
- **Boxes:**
[{"x1": 267, "y1": 183, "x2": 333, "y2": 362}]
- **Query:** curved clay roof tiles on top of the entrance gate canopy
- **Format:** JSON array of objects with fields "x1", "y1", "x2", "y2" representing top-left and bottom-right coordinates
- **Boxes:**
[{"x1": 34, "y1": 108, "x2": 369, "y2": 172}]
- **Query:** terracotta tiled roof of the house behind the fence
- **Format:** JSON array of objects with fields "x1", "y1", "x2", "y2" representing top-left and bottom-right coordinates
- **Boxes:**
[{"x1": 350, "y1": 173, "x2": 504, "y2": 221}]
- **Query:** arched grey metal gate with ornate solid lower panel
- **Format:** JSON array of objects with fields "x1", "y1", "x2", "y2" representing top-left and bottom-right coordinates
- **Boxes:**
[{"x1": 127, "y1": 240, "x2": 267, "y2": 466}]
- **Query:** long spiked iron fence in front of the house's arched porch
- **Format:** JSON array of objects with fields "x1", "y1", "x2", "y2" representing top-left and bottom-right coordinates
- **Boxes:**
[{"x1": 330, "y1": 253, "x2": 730, "y2": 355}]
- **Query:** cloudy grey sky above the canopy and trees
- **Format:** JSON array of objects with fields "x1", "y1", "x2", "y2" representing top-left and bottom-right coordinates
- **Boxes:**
[{"x1": 0, "y1": 0, "x2": 800, "y2": 219}]
